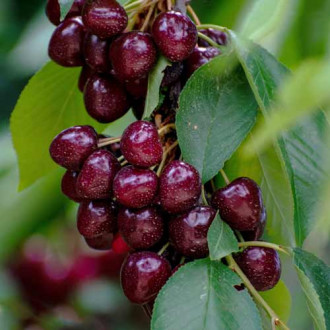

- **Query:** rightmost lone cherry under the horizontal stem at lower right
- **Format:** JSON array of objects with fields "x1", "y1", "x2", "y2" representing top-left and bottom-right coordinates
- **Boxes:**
[{"x1": 234, "y1": 246, "x2": 281, "y2": 291}]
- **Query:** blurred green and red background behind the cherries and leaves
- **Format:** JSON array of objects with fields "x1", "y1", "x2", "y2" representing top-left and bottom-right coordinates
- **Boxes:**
[{"x1": 0, "y1": 0, "x2": 330, "y2": 330}]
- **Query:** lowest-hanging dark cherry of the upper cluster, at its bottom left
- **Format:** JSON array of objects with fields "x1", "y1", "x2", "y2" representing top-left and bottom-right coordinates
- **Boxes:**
[{"x1": 84, "y1": 74, "x2": 130, "y2": 123}]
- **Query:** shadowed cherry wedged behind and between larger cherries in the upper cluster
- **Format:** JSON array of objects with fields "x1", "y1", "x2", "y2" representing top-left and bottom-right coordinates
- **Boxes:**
[{"x1": 84, "y1": 33, "x2": 111, "y2": 73}]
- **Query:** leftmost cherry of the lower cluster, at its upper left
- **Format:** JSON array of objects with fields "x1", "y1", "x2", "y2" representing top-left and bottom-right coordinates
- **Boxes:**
[{"x1": 49, "y1": 126, "x2": 97, "y2": 171}]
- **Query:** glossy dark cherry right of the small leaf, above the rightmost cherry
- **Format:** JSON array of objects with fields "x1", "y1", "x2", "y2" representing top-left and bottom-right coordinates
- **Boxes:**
[{"x1": 211, "y1": 178, "x2": 264, "y2": 231}]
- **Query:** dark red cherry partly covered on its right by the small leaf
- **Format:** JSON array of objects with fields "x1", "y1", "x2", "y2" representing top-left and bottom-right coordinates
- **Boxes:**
[{"x1": 169, "y1": 206, "x2": 216, "y2": 258}]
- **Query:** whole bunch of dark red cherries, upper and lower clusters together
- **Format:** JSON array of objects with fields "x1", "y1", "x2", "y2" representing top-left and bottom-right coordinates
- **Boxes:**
[{"x1": 47, "y1": 0, "x2": 281, "y2": 314}]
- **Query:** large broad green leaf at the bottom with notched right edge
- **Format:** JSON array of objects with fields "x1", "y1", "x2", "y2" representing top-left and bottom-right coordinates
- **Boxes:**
[{"x1": 151, "y1": 259, "x2": 261, "y2": 330}]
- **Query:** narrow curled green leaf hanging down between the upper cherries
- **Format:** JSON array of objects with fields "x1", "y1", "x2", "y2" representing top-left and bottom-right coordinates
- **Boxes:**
[{"x1": 142, "y1": 56, "x2": 171, "y2": 118}]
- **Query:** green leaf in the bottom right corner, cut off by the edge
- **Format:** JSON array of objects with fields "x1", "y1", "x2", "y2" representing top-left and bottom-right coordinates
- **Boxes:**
[{"x1": 293, "y1": 248, "x2": 330, "y2": 330}]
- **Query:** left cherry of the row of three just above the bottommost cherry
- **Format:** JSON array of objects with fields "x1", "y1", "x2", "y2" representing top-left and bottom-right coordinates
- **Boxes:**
[{"x1": 77, "y1": 200, "x2": 117, "y2": 238}]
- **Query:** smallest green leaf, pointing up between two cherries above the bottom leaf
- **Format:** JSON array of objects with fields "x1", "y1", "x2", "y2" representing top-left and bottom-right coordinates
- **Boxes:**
[{"x1": 207, "y1": 214, "x2": 239, "y2": 260}]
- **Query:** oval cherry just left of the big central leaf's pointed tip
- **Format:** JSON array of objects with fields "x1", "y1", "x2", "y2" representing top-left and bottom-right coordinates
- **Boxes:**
[{"x1": 159, "y1": 160, "x2": 201, "y2": 213}]
